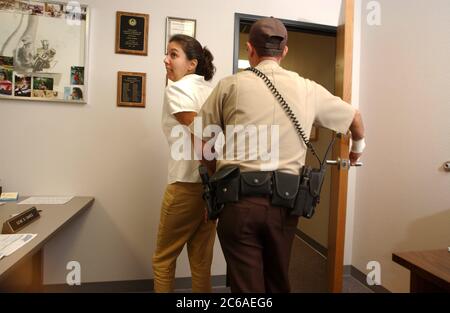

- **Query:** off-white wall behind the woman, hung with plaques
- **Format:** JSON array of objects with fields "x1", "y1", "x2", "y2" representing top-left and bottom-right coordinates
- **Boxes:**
[{"x1": 0, "y1": 0, "x2": 341, "y2": 284}]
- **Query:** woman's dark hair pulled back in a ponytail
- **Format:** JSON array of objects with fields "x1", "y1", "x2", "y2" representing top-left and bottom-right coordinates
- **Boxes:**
[{"x1": 169, "y1": 35, "x2": 216, "y2": 81}]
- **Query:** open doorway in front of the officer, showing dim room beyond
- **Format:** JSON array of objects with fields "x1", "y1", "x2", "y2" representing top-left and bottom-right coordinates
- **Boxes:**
[{"x1": 233, "y1": 13, "x2": 337, "y2": 292}]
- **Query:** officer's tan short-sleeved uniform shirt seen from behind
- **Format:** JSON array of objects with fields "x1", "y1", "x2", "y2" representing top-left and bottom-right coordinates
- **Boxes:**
[{"x1": 190, "y1": 60, "x2": 355, "y2": 174}]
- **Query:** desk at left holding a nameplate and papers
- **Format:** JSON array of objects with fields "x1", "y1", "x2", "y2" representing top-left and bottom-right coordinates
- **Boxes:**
[{"x1": 0, "y1": 197, "x2": 94, "y2": 291}]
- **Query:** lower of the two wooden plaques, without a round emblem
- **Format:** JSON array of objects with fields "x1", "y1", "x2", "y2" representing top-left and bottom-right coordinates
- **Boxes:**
[{"x1": 117, "y1": 72, "x2": 146, "y2": 108}]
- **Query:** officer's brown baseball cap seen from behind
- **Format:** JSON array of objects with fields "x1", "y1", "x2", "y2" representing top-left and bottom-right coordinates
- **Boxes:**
[{"x1": 248, "y1": 17, "x2": 287, "y2": 55}]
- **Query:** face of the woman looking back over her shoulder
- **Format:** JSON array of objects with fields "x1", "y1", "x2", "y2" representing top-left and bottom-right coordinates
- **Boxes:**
[{"x1": 164, "y1": 41, "x2": 197, "y2": 82}]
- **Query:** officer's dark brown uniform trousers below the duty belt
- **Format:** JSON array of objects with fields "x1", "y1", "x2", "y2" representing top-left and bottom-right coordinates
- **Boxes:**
[{"x1": 217, "y1": 196, "x2": 298, "y2": 293}]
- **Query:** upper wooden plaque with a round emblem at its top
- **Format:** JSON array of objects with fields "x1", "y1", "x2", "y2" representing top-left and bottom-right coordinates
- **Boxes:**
[{"x1": 116, "y1": 12, "x2": 149, "y2": 55}]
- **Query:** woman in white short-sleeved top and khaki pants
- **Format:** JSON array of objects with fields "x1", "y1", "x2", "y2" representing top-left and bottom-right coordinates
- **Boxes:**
[{"x1": 153, "y1": 35, "x2": 216, "y2": 292}]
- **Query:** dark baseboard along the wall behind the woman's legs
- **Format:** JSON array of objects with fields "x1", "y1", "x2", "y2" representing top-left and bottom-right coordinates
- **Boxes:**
[{"x1": 43, "y1": 275, "x2": 226, "y2": 293}]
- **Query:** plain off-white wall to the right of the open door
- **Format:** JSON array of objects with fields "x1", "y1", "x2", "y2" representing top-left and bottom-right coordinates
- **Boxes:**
[{"x1": 352, "y1": 0, "x2": 450, "y2": 292}]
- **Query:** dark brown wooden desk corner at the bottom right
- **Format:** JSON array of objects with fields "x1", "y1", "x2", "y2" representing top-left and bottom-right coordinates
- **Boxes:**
[{"x1": 392, "y1": 249, "x2": 450, "y2": 292}]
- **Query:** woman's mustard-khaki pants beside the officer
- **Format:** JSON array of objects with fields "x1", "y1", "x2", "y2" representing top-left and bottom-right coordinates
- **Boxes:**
[{"x1": 153, "y1": 182, "x2": 216, "y2": 292}]
